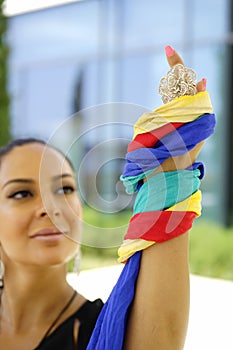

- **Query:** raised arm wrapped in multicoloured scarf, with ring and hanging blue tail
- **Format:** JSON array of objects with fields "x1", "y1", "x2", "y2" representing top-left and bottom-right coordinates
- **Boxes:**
[{"x1": 88, "y1": 47, "x2": 215, "y2": 350}]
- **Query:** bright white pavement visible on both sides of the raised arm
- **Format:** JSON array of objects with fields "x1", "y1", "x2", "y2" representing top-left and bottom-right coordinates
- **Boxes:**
[{"x1": 67, "y1": 265, "x2": 233, "y2": 350}]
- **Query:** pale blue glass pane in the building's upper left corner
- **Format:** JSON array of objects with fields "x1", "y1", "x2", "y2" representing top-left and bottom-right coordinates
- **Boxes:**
[{"x1": 8, "y1": 1, "x2": 100, "y2": 65}]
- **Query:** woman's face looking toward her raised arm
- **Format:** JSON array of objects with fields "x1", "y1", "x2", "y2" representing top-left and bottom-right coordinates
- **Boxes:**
[{"x1": 0, "y1": 143, "x2": 81, "y2": 266}]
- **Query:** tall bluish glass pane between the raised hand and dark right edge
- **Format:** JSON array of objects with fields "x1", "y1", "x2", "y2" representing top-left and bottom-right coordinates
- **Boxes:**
[{"x1": 193, "y1": 45, "x2": 228, "y2": 222}]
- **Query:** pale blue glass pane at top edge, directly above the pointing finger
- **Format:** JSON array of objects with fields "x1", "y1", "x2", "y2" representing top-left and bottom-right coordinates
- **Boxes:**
[{"x1": 121, "y1": 0, "x2": 185, "y2": 51}]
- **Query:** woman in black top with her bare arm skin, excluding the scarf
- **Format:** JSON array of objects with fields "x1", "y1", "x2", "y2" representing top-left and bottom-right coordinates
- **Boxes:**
[{"x1": 0, "y1": 47, "x2": 213, "y2": 350}]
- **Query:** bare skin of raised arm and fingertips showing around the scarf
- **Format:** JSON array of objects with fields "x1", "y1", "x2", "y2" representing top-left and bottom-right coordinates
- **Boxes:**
[{"x1": 124, "y1": 47, "x2": 213, "y2": 350}]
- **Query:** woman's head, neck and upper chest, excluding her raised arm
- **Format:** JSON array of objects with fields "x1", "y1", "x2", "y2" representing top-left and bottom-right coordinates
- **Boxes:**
[{"x1": 0, "y1": 139, "x2": 102, "y2": 349}]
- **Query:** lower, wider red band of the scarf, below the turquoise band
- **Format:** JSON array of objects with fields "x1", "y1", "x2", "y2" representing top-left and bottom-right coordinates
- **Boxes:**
[{"x1": 124, "y1": 211, "x2": 197, "y2": 243}]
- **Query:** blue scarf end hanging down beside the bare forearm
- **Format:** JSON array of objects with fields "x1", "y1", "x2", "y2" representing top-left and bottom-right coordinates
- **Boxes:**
[{"x1": 87, "y1": 251, "x2": 141, "y2": 350}]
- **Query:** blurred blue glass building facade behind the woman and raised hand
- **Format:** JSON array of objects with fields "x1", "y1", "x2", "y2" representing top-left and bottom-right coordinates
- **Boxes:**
[{"x1": 4, "y1": 0, "x2": 233, "y2": 223}]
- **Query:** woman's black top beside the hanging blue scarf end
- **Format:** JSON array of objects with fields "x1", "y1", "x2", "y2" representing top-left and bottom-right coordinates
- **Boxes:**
[{"x1": 34, "y1": 299, "x2": 103, "y2": 350}]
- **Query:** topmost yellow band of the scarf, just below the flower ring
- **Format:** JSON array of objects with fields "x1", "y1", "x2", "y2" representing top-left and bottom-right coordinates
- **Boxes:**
[{"x1": 134, "y1": 91, "x2": 213, "y2": 138}]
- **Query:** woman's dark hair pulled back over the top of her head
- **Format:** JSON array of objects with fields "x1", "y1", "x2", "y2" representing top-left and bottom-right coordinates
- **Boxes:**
[{"x1": 0, "y1": 137, "x2": 75, "y2": 171}]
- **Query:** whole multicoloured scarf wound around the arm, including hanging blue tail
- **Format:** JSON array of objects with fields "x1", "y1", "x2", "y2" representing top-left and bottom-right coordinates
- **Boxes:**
[{"x1": 87, "y1": 92, "x2": 215, "y2": 350}]
